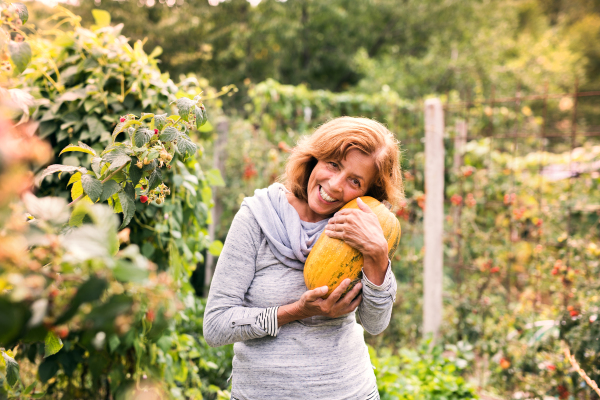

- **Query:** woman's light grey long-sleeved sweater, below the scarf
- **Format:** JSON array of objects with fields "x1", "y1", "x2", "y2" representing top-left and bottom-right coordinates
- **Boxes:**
[{"x1": 204, "y1": 205, "x2": 396, "y2": 400}]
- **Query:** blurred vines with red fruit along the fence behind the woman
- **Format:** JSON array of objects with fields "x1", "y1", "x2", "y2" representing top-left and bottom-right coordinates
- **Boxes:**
[{"x1": 221, "y1": 80, "x2": 600, "y2": 397}]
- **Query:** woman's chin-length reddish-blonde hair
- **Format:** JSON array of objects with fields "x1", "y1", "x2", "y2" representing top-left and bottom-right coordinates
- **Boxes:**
[{"x1": 282, "y1": 117, "x2": 404, "y2": 209}]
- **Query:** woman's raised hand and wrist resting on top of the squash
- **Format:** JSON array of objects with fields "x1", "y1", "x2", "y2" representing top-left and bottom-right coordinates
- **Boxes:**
[{"x1": 324, "y1": 197, "x2": 388, "y2": 285}]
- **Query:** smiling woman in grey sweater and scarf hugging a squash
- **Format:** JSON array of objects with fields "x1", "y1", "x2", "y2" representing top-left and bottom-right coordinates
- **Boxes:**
[{"x1": 204, "y1": 117, "x2": 403, "y2": 400}]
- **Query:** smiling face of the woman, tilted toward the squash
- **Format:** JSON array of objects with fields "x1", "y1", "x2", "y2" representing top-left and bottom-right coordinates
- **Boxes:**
[{"x1": 307, "y1": 149, "x2": 377, "y2": 220}]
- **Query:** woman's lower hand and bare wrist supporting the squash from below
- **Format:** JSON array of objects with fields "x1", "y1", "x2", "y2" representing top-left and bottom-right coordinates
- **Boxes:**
[{"x1": 277, "y1": 279, "x2": 362, "y2": 326}]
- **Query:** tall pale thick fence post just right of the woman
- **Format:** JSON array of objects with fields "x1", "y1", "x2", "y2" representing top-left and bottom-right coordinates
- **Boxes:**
[{"x1": 423, "y1": 98, "x2": 444, "y2": 338}]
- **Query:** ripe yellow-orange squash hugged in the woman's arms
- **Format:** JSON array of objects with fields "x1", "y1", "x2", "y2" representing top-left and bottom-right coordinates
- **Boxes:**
[{"x1": 304, "y1": 196, "x2": 400, "y2": 298}]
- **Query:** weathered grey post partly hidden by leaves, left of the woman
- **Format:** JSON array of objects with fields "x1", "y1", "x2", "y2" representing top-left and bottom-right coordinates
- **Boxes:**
[{"x1": 204, "y1": 117, "x2": 229, "y2": 297}]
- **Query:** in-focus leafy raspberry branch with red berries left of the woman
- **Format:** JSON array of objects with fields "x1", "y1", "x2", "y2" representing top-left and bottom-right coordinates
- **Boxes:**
[{"x1": 37, "y1": 96, "x2": 207, "y2": 227}]
